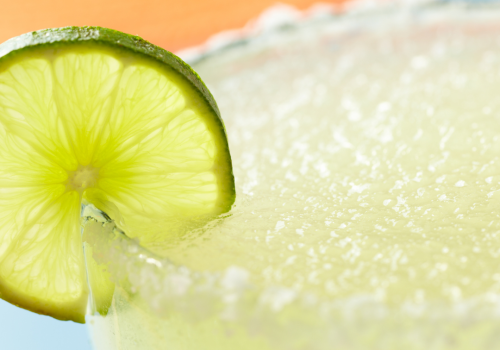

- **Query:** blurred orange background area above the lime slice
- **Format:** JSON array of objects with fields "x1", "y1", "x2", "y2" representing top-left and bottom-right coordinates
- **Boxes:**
[{"x1": 0, "y1": 0, "x2": 344, "y2": 51}]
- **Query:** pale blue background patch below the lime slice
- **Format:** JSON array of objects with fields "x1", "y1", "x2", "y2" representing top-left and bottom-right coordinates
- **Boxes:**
[{"x1": 0, "y1": 299, "x2": 92, "y2": 350}]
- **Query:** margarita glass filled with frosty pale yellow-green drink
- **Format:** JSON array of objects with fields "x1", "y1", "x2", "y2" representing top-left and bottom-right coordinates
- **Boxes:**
[{"x1": 87, "y1": 3, "x2": 500, "y2": 350}]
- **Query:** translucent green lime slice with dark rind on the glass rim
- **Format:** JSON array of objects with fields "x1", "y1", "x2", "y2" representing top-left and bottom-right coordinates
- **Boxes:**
[{"x1": 0, "y1": 27, "x2": 235, "y2": 323}]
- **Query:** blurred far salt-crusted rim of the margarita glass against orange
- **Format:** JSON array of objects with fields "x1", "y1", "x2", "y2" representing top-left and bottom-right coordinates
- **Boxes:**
[{"x1": 175, "y1": 0, "x2": 500, "y2": 65}]
